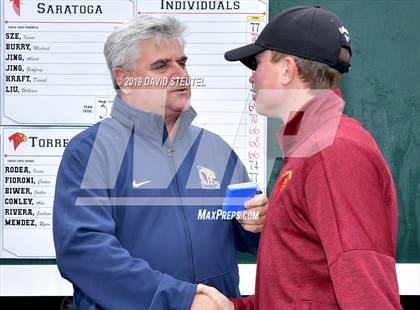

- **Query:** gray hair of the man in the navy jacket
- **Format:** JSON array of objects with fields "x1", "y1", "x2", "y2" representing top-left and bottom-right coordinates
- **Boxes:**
[{"x1": 104, "y1": 15, "x2": 186, "y2": 91}]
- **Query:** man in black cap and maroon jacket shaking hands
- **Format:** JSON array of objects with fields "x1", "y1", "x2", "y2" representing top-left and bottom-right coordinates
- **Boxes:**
[{"x1": 199, "y1": 7, "x2": 402, "y2": 310}]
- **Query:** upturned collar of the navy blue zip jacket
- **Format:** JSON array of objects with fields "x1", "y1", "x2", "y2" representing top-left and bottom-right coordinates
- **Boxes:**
[{"x1": 111, "y1": 96, "x2": 197, "y2": 144}]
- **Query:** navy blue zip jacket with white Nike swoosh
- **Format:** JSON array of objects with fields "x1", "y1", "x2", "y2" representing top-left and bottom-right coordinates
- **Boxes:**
[{"x1": 53, "y1": 97, "x2": 259, "y2": 310}]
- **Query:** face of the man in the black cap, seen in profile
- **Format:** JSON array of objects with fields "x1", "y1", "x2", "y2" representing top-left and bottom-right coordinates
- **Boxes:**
[{"x1": 249, "y1": 50, "x2": 283, "y2": 118}]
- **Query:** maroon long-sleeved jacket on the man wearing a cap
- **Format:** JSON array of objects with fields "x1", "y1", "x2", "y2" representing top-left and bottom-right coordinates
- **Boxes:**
[{"x1": 232, "y1": 91, "x2": 402, "y2": 310}]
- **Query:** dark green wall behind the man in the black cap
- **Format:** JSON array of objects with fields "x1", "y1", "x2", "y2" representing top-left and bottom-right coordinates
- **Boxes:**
[{"x1": 267, "y1": 0, "x2": 420, "y2": 263}]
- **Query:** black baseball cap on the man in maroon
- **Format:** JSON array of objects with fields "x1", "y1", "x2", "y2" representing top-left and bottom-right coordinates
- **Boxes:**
[{"x1": 225, "y1": 6, "x2": 351, "y2": 73}]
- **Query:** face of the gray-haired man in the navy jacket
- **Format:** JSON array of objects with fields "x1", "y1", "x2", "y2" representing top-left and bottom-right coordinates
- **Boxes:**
[{"x1": 120, "y1": 38, "x2": 191, "y2": 117}]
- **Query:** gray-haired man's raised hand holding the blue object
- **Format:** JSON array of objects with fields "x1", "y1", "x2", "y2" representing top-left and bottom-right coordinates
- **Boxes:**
[{"x1": 238, "y1": 195, "x2": 268, "y2": 233}]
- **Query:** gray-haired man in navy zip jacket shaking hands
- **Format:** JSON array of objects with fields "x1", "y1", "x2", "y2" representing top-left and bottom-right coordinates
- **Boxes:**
[{"x1": 54, "y1": 16, "x2": 268, "y2": 310}]
